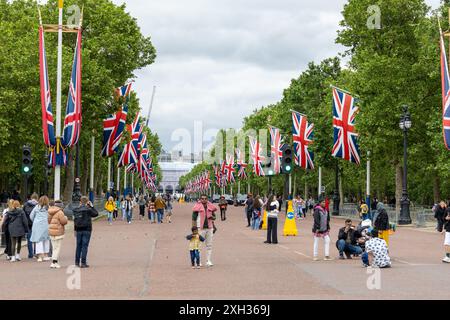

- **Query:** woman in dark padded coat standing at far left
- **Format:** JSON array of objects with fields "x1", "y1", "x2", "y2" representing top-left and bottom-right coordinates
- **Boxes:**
[{"x1": 6, "y1": 200, "x2": 29, "y2": 262}]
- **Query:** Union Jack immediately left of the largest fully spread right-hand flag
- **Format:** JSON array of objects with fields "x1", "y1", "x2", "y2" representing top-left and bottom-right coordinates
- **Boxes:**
[{"x1": 292, "y1": 111, "x2": 314, "y2": 170}]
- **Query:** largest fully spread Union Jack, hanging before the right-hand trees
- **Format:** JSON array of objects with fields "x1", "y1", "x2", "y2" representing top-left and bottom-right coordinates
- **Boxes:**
[{"x1": 332, "y1": 88, "x2": 360, "y2": 164}]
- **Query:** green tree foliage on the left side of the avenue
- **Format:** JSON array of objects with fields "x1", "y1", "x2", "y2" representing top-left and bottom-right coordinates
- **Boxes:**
[{"x1": 0, "y1": 0, "x2": 161, "y2": 195}]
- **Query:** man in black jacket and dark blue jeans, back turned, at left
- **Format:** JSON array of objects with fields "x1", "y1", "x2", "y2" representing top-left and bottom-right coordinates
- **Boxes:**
[{"x1": 73, "y1": 197, "x2": 98, "y2": 268}]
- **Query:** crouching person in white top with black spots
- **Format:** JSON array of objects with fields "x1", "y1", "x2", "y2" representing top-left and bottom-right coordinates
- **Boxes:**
[{"x1": 361, "y1": 229, "x2": 391, "y2": 268}]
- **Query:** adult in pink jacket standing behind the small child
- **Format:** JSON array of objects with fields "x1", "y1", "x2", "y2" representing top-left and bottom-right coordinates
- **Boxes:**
[{"x1": 192, "y1": 194, "x2": 217, "y2": 267}]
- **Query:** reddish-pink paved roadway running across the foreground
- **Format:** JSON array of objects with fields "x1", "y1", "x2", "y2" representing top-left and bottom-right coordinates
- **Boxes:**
[{"x1": 0, "y1": 204, "x2": 450, "y2": 300}]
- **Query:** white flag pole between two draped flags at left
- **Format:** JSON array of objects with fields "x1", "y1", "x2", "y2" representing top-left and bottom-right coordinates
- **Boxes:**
[{"x1": 54, "y1": 0, "x2": 63, "y2": 200}]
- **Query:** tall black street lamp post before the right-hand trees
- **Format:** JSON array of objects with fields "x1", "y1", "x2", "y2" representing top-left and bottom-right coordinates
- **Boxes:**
[{"x1": 398, "y1": 105, "x2": 412, "y2": 225}]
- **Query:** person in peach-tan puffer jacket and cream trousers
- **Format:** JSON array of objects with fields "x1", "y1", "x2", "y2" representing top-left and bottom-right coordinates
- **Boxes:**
[{"x1": 48, "y1": 197, "x2": 68, "y2": 269}]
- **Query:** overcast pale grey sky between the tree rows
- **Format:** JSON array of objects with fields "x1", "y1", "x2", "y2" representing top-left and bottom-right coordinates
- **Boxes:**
[{"x1": 113, "y1": 0, "x2": 439, "y2": 151}]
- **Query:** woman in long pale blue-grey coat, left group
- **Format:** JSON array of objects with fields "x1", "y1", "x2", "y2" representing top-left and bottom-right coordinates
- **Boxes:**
[{"x1": 30, "y1": 196, "x2": 50, "y2": 262}]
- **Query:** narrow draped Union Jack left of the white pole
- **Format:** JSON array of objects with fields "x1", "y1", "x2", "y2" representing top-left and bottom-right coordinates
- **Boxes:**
[{"x1": 39, "y1": 25, "x2": 56, "y2": 147}]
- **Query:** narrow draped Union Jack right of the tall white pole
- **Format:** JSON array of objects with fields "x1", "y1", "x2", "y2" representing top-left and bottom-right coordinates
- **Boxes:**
[{"x1": 63, "y1": 28, "x2": 81, "y2": 147}]
